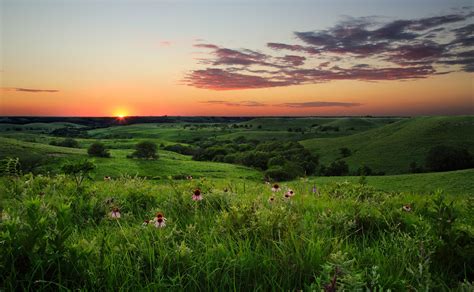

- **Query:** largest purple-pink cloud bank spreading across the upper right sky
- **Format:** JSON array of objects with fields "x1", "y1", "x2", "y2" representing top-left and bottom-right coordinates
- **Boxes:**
[{"x1": 184, "y1": 8, "x2": 474, "y2": 90}]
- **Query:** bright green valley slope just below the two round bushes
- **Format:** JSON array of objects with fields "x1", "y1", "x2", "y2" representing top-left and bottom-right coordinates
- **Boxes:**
[{"x1": 0, "y1": 137, "x2": 261, "y2": 179}]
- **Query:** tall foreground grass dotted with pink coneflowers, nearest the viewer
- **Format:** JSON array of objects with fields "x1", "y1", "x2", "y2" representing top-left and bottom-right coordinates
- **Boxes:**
[{"x1": 0, "y1": 175, "x2": 474, "y2": 291}]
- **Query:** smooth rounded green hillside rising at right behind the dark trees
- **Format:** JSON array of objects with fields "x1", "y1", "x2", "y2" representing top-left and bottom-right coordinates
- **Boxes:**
[{"x1": 301, "y1": 116, "x2": 474, "y2": 174}]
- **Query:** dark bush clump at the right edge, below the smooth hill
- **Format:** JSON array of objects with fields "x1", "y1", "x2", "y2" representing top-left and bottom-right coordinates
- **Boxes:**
[{"x1": 426, "y1": 146, "x2": 474, "y2": 171}]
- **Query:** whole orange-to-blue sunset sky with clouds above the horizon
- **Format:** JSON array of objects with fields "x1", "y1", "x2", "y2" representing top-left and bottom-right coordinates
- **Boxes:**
[{"x1": 0, "y1": 0, "x2": 474, "y2": 116}]
